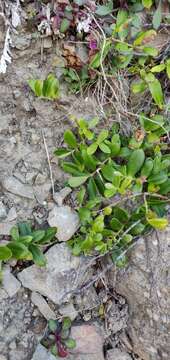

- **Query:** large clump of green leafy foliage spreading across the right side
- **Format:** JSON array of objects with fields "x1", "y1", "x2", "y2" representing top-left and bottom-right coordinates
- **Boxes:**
[{"x1": 55, "y1": 114, "x2": 170, "y2": 265}]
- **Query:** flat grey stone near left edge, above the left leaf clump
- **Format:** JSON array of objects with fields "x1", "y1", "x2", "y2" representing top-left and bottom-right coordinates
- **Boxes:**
[{"x1": 3, "y1": 176, "x2": 34, "y2": 200}]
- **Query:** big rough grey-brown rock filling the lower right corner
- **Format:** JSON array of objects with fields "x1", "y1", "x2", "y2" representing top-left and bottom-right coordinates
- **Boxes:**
[{"x1": 116, "y1": 228, "x2": 170, "y2": 360}]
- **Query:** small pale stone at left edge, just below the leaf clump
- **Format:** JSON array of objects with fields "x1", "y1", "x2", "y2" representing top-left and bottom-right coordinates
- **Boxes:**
[{"x1": 2, "y1": 266, "x2": 21, "y2": 297}]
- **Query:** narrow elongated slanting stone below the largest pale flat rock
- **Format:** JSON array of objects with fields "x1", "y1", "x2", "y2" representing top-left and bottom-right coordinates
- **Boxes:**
[{"x1": 31, "y1": 291, "x2": 56, "y2": 320}]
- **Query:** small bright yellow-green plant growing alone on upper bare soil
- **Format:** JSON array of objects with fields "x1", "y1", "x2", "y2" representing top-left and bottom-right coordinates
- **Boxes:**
[{"x1": 28, "y1": 74, "x2": 60, "y2": 100}]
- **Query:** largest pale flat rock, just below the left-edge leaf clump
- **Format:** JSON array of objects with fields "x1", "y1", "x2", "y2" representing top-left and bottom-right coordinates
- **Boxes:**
[{"x1": 18, "y1": 244, "x2": 82, "y2": 304}]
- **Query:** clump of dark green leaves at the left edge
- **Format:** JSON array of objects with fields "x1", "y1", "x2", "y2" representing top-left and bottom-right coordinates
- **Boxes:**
[{"x1": 0, "y1": 222, "x2": 57, "y2": 266}]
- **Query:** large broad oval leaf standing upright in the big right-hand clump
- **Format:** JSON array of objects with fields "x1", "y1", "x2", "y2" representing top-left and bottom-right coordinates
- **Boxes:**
[{"x1": 127, "y1": 149, "x2": 145, "y2": 177}]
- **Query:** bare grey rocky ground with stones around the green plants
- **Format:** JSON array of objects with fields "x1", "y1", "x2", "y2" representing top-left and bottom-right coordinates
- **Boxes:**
[{"x1": 0, "y1": 1, "x2": 170, "y2": 360}]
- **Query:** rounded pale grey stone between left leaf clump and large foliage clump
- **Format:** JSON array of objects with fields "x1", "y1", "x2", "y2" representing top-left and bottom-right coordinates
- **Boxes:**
[{"x1": 48, "y1": 206, "x2": 79, "y2": 241}]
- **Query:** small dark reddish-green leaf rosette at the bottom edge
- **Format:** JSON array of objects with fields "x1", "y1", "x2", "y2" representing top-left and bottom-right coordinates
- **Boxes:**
[{"x1": 42, "y1": 317, "x2": 76, "y2": 358}]
